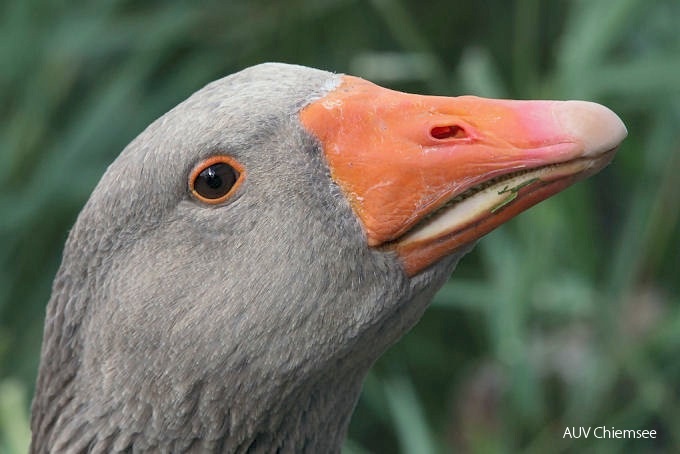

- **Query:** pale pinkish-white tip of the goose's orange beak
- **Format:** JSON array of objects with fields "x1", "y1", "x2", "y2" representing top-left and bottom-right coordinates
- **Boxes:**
[{"x1": 553, "y1": 101, "x2": 628, "y2": 157}]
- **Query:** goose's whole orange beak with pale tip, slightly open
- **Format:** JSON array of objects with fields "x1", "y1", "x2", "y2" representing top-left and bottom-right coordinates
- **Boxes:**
[{"x1": 300, "y1": 76, "x2": 627, "y2": 276}]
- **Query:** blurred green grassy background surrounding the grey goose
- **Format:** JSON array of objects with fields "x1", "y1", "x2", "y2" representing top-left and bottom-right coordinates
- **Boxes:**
[{"x1": 0, "y1": 0, "x2": 680, "y2": 454}]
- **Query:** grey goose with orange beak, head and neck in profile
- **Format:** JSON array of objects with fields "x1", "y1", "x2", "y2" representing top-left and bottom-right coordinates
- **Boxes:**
[{"x1": 31, "y1": 63, "x2": 627, "y2": 453}]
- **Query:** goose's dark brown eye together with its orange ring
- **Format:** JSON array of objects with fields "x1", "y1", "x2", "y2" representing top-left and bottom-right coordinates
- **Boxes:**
[{"x1": 189, "y1": 155, "x2": 245, "y2": 205}]
